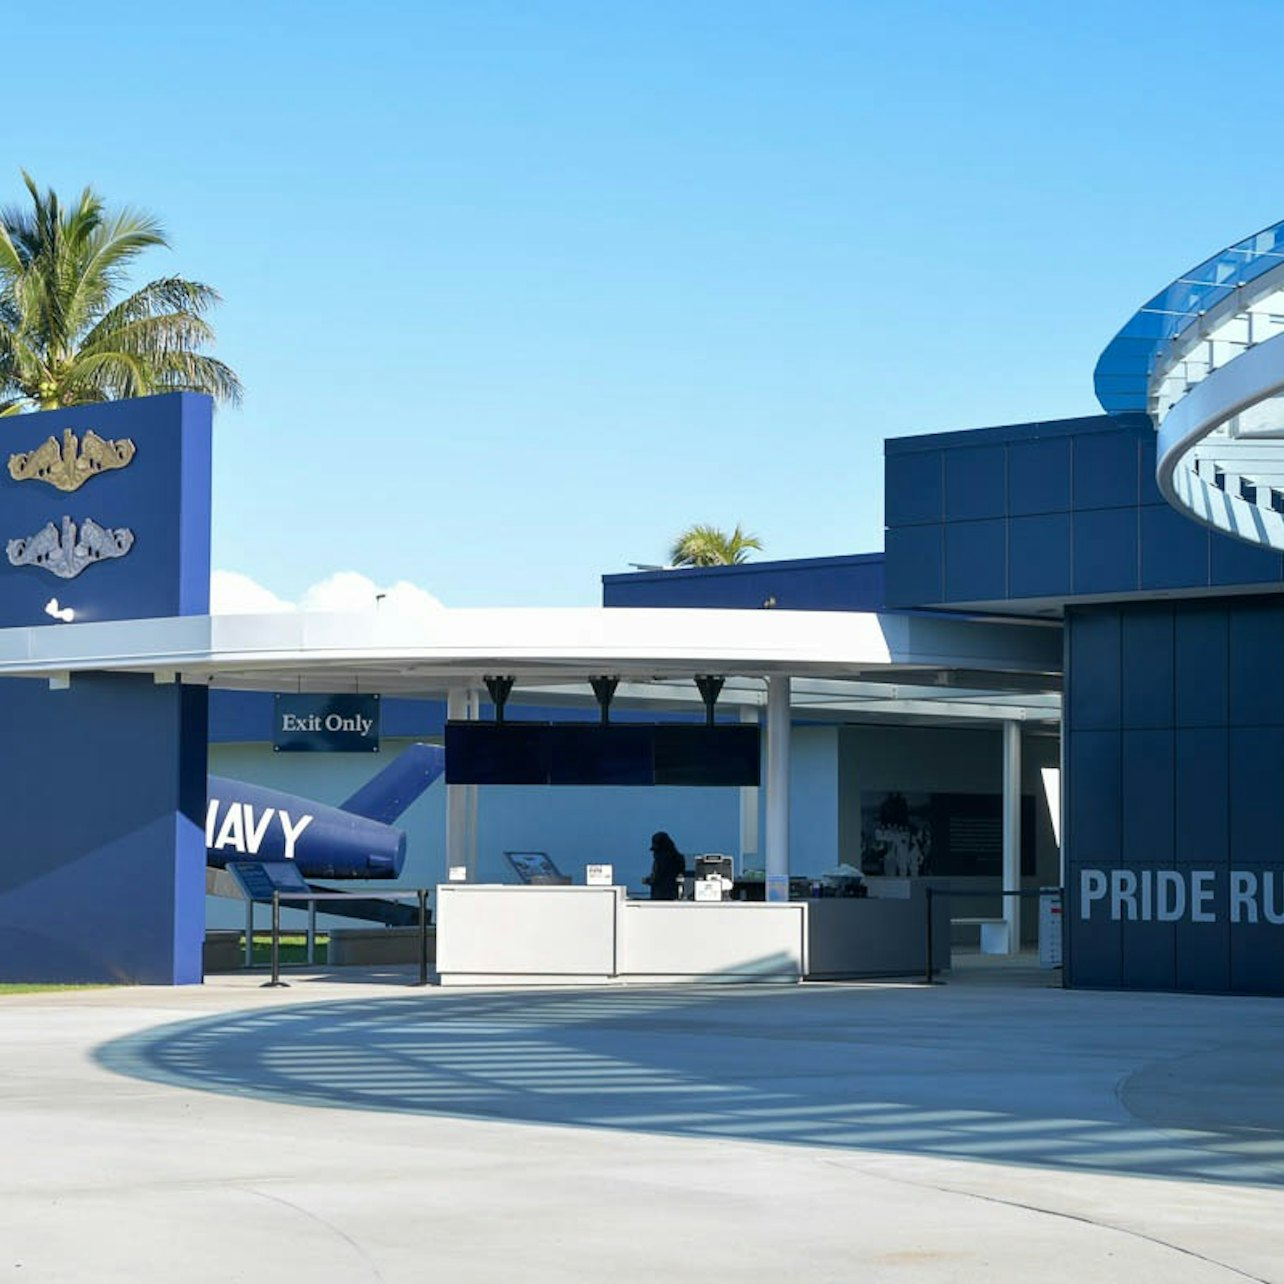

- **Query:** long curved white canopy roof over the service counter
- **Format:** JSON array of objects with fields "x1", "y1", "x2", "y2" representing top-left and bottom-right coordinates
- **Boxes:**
[{"x1": 0, "y1": 607, "x2": 1061, "y2": 719}]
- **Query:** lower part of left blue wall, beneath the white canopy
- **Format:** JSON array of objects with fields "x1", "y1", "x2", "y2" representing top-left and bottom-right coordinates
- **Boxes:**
[{"x1": 0, "y1": 674, "x2": 205, "y2": 985}]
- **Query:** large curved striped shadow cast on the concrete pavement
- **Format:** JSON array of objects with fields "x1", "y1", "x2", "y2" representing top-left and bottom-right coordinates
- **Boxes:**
[{"x1": 96, "y1": 986, "x2": 1284, "y2": 1185}]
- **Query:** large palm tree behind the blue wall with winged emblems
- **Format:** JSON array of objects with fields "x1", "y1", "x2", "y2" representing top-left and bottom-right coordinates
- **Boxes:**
[{"x1": 0, "y1": 171, "x2": 241, "y2": 415}]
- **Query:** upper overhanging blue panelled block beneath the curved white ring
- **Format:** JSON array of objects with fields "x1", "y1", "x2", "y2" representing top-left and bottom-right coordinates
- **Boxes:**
[{"x1": 885, "y1": 415, "x2": 1284, "y2": 607}]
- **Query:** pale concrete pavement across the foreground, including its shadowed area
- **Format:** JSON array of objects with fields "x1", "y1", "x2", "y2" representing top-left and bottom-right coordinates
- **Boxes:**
[{"x1": 0, "y1": 977, "x2": 1284, "y2": 1284}]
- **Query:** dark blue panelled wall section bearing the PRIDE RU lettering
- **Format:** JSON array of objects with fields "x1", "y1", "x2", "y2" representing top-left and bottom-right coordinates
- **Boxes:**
[{"x1": 1063, "y1": 597, "x2": 1284, "y2": 994}]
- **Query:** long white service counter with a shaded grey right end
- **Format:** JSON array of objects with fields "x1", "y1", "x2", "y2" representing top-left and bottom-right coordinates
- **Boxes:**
[{"x1": 437, "y1": 883, "x2": 949, "y2": 985}]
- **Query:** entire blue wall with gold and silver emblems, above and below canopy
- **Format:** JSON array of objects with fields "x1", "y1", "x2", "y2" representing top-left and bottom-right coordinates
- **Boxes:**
[{"x1": 0, "y1": 393, "x2": 211, "y2": 984}]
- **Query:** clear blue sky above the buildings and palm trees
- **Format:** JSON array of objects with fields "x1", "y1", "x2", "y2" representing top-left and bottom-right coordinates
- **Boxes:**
[{"x1": 10, "y1": 0, "x2": 1284, "y2": 606}]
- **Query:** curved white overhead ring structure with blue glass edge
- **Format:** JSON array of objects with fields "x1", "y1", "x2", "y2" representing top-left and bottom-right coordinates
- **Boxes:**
[{"x1": 1095, "y1": 222, "x2": 1284, "y2": 550}]
